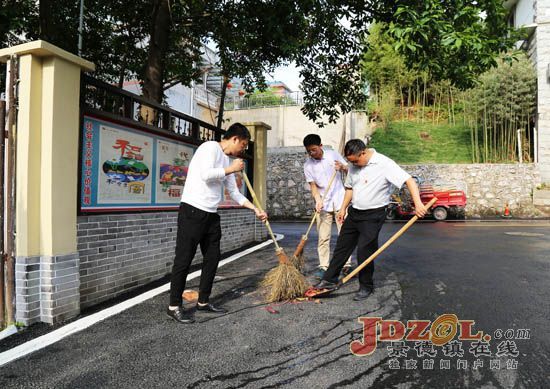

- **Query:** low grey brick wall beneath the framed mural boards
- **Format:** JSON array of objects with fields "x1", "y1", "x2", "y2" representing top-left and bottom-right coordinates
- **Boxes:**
[{"x1": 78, "y1": 209, "x2": 267, "y2": 308}]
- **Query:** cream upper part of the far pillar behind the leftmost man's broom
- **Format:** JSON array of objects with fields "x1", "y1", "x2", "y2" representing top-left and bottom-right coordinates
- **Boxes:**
[{"x1": 243, "y1": 122, "x2": 271, "y2": 209}]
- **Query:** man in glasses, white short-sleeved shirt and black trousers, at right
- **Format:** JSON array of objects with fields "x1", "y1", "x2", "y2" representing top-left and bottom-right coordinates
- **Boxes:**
[{"x1": 316, "y1": 139, "x2": 427, "y2": 301}]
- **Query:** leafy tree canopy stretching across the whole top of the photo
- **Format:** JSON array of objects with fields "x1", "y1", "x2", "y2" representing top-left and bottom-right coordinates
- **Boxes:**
[{"x1": 2, "y1": 0, "x2": 512, "y2": 125}]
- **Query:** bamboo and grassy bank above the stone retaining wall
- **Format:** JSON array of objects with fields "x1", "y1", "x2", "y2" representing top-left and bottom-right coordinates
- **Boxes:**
[{"x1": 363, "y1": 24, "x2": 537, "y2": 163}]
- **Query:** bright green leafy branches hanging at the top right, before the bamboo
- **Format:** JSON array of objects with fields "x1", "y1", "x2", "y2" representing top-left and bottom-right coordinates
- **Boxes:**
[{"x1": 388, "y1": 0, "x2": 519, "y2": 88}]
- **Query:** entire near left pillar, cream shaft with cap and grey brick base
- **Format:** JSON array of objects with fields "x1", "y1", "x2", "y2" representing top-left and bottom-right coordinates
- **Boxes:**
[{"x1": 0, "y1": 41, "x2": 94, "y2": 324}]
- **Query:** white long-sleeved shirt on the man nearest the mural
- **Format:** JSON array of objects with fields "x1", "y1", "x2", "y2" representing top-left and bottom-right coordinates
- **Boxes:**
[{"x1": 181, "y1": 141, "x2": 246, "y2": 213}]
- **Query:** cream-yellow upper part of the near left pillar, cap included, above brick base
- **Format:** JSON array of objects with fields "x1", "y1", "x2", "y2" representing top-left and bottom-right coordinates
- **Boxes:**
[{"x1": 0, "y1": 41, "x2": 95, "y2": 257}]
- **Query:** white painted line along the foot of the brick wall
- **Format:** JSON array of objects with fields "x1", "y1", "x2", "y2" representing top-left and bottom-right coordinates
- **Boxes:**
[{"x1": 0, "y1": 234, "x2": 284, "y2": 366}]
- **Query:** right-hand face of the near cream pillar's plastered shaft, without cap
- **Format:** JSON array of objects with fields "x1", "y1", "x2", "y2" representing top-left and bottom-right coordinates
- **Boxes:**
[{"x1": 40, "y1": 57, "x2": 87, "y2": 255}]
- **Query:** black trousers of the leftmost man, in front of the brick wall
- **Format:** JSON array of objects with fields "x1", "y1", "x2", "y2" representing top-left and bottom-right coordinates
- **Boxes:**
[{"x1": 170, "y1": 203, "x2": 222, "y2": 306}]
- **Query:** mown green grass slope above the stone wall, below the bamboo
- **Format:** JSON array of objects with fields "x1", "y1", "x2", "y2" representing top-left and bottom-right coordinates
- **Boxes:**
[{"x1": 369, "y1": 121, "x2": 472, "y2": 163}]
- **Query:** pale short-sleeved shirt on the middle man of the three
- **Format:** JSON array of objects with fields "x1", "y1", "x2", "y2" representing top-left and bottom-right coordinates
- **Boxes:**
[{"x1": 304, "y1": 149, "x2": 347, "y2": 212}]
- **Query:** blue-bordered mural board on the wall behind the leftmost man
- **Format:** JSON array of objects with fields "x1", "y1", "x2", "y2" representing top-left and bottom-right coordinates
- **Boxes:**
[{"x1": 80, "y1": 115, "x2": 246, "y2": 212}]
